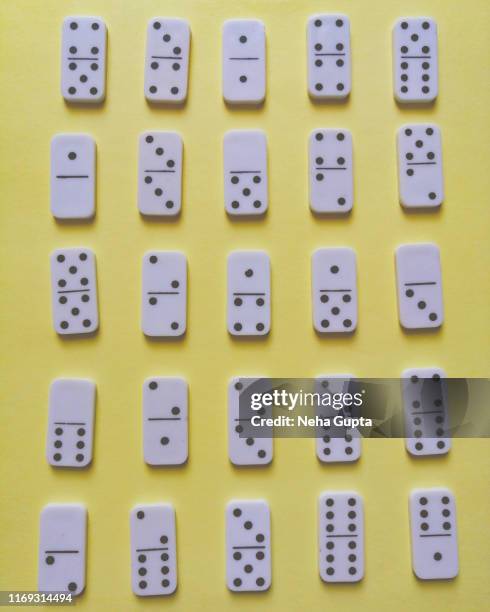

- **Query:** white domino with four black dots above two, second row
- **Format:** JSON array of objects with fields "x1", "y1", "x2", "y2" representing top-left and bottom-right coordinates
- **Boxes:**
[{"x1": 309, "y1": 128, "x2": 354, "y2": 214}]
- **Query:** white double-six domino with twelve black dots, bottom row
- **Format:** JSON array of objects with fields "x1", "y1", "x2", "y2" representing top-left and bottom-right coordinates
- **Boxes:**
[{"x1": 318, "y1": 491, "x2": 364, "y2": 582}]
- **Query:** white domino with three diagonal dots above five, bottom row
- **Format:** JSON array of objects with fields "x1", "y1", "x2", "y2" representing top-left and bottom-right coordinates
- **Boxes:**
[{"x1": 226, "y1": 500, "x2": 271, "y2": 591}]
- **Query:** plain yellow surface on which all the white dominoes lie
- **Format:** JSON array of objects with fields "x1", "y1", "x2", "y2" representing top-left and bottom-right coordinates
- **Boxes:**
[{"x1": 0, "y1": 0, "x2": 490, "y2": 612}]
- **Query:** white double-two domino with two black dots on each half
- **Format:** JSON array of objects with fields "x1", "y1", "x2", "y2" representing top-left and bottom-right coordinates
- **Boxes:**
[{"x1": 141, "y1": 251, "x2": 187, "y2": 337}]
